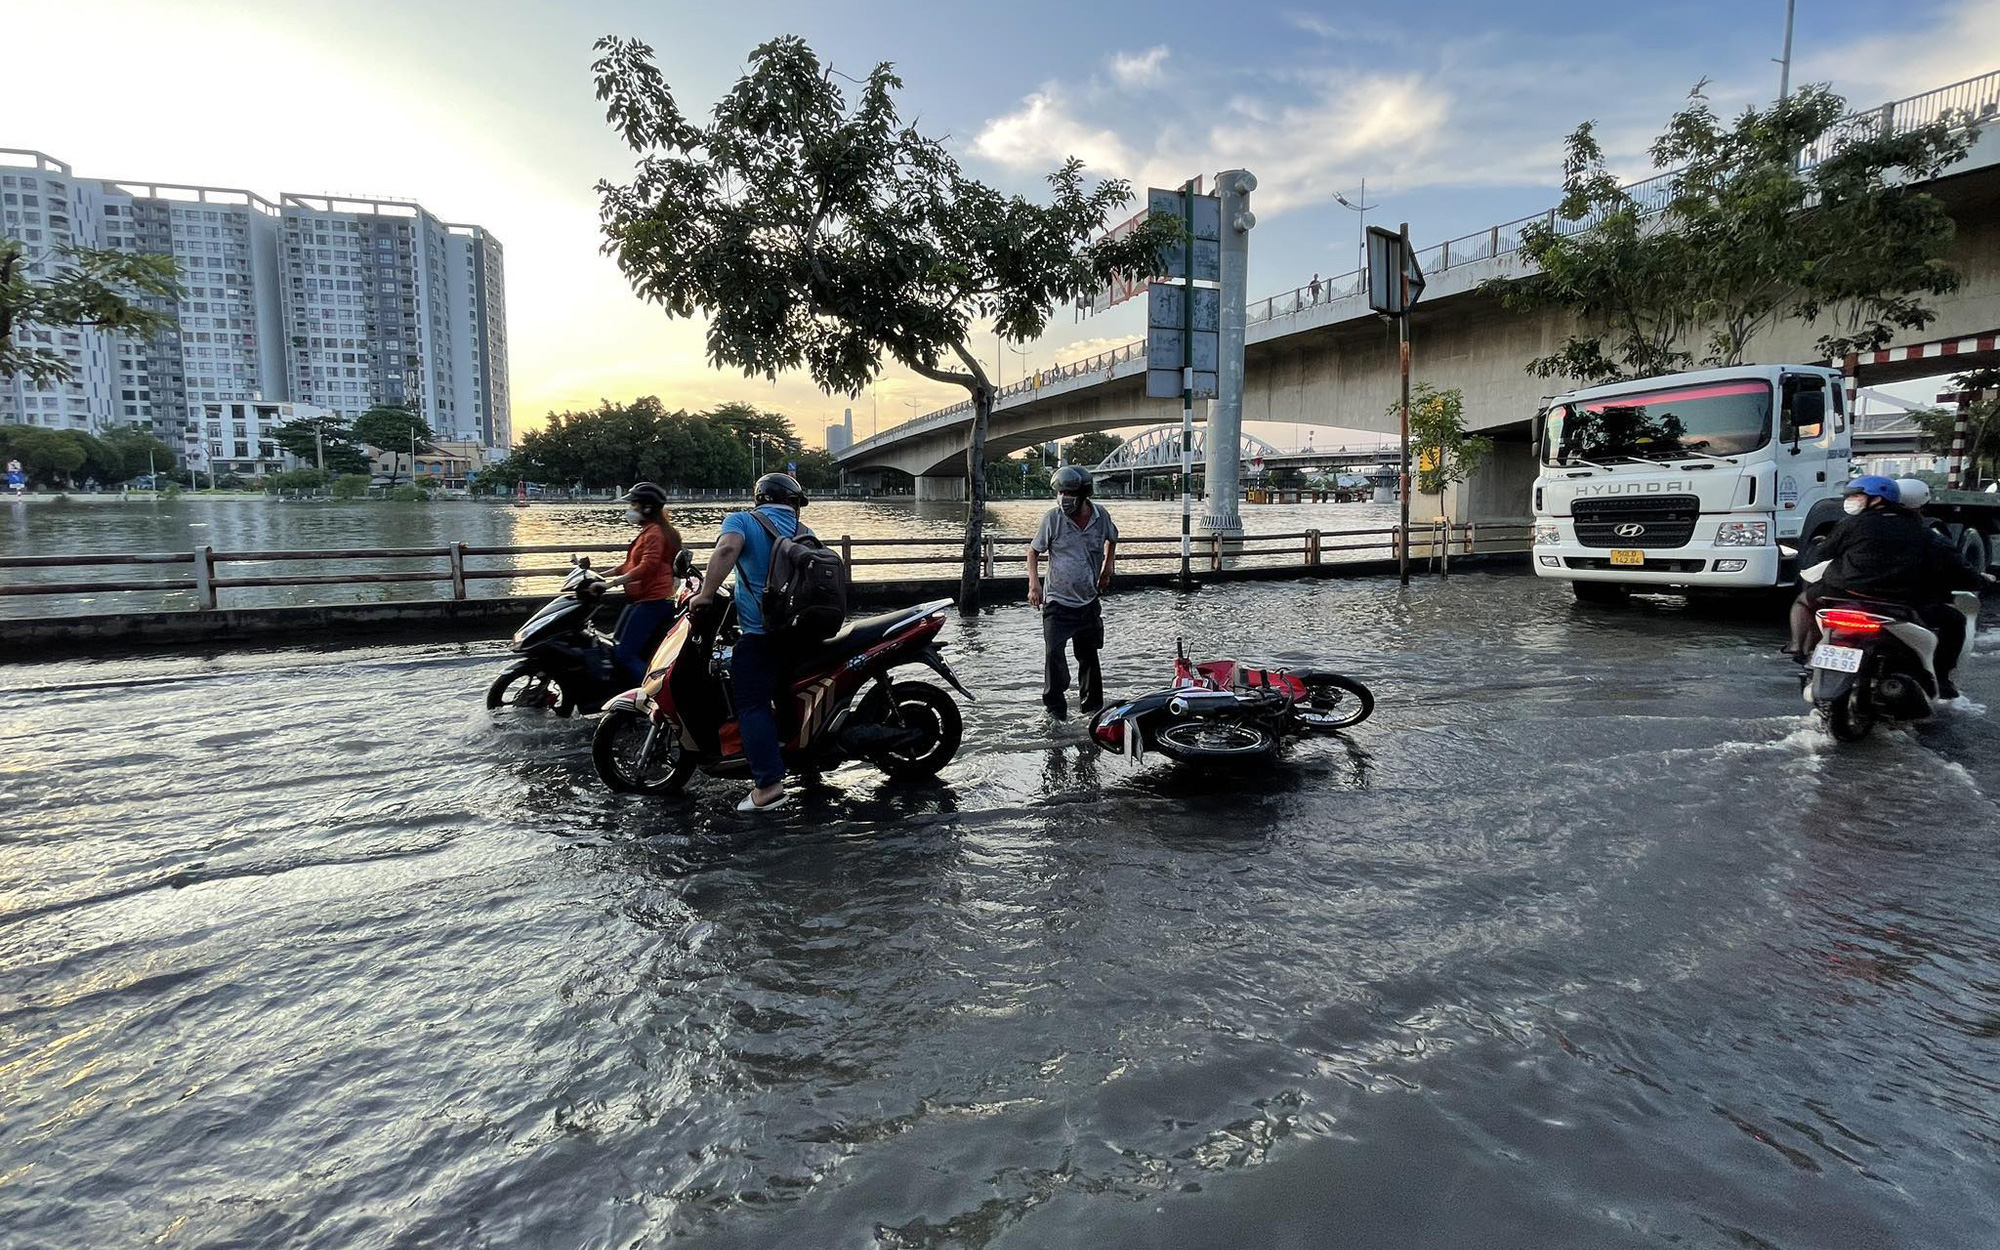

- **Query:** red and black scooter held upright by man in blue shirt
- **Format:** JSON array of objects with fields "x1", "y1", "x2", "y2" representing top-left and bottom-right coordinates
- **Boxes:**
[{"x1": 590, "y1": 588, "x2": 972, "y2": 794}]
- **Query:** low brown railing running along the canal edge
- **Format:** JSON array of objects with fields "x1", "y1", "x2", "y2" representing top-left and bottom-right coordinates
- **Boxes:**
[{"x1": 0, "y1": 522, "x2": 1528, "y2": 612}]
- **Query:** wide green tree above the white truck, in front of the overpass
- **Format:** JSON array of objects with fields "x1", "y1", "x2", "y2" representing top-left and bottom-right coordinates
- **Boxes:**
[{"x1": 1488, "y1": 84, "x2": 1976, "y2": 382}]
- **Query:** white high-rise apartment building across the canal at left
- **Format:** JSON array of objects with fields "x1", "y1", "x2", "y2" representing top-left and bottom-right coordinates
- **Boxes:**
[{"x1": 0, "y1": 148, "x2": 512, "y2": 462}]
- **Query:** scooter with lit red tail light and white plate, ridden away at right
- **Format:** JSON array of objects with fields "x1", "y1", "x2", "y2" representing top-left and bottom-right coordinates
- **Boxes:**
[{"x1": 1806, "y1": 590, "x2": 1980, "y2": 742}]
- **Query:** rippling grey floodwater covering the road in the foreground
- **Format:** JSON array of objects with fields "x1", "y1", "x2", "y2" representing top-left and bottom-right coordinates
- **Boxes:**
[{"x1": 0, "y1": 574, "x2": 2000, "y2": 1250}]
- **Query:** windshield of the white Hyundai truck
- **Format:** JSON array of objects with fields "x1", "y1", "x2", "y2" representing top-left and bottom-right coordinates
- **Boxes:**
[{"x1": 1544, "y1": 380, "x2": 1770, "y2": 464}]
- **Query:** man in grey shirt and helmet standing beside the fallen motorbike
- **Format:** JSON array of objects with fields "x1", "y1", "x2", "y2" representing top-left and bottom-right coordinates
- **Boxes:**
[{"x1": 1028, "y1": 464, "x2": 1118, "y2": 720}]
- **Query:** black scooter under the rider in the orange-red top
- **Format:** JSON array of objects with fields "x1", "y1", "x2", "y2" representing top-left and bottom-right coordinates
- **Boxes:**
[{"x1": 486, "y1": 550, "x2": 698, "y2": 716}]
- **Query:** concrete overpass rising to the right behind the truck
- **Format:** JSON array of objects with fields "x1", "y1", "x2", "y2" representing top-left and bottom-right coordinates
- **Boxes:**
[{"x1": 838, "y1": 70, "x2": 2000, "y2": 518}]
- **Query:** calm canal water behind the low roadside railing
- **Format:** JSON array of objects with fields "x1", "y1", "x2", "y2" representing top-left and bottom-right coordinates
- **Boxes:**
[{"x1": 0, "y1": 496, "x2": 1408, "y2": 618}]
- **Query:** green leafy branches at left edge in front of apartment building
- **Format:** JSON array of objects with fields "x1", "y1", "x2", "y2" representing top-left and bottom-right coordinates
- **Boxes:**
[{"x1": 0, "y1": 238, "x2": 180, "y2": 386}]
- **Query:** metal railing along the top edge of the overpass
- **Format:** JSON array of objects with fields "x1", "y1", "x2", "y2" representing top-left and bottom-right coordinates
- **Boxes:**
[{"x1": 848, "y1": 70, "x2": 2000, "y2": 452}]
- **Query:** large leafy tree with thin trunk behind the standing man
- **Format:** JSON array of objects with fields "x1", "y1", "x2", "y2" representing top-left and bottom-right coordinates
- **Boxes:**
[{"x1": 592, "y1": 36, "x2": 1180, "y2": 612}]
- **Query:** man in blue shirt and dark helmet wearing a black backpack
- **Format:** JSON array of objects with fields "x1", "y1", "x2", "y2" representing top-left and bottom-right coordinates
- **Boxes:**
[{"x1": 688, "y1": 474, "x2": 806, "y2": 812}]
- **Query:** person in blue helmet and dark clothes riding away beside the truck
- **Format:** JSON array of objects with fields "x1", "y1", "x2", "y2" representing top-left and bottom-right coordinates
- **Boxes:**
[{"x1": 1790, "y1": 474, "x2": 1992, "y2": 698}]
